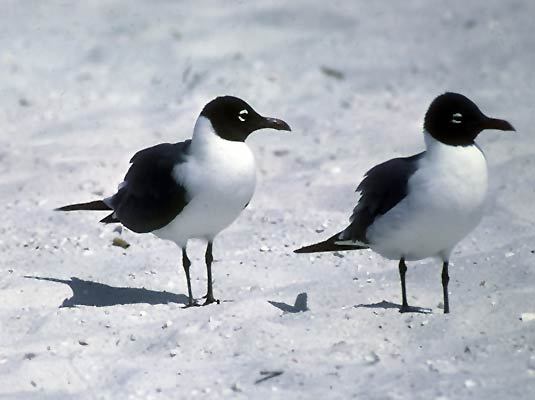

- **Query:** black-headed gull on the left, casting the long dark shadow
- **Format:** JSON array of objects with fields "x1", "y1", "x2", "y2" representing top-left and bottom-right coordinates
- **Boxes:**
[{"x1": 57, "y1": 96, "x2": 290, "y2": 306}]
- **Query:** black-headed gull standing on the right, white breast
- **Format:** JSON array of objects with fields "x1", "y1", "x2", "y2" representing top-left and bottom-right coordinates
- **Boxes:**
[{"x1": 295, "y1": 93, "x2": 515, "y2": 313}]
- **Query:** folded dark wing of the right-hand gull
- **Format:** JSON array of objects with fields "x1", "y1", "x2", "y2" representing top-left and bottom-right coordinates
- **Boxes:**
[{"x1": 340, "y1": 152, "x2": 424, "y2": 244}]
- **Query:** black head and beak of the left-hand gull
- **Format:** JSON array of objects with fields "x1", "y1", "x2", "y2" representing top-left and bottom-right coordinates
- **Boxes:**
[{"x1": 201, "y1": 96, "x2": 291, "y2": 142}]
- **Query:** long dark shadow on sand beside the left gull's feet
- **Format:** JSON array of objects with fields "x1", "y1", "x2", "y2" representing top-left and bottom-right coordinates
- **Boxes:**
[{"x1": 25, "y1": 276, "x2": 188, "y2": 308}]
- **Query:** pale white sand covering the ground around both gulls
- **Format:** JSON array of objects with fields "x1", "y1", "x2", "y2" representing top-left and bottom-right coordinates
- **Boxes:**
[{"x1": 0, "y1": 0, "x2": 535, "y2": 400}]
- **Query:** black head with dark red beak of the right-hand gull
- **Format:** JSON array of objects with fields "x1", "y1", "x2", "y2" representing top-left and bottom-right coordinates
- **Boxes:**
[{"x1": 424, "y1": 92, "x2": 515, "y2": 146}]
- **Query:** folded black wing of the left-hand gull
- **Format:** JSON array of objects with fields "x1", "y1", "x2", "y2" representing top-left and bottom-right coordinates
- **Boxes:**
[{"x1": 101, "y1": 140, "x2": 191, "y2": 233}]
